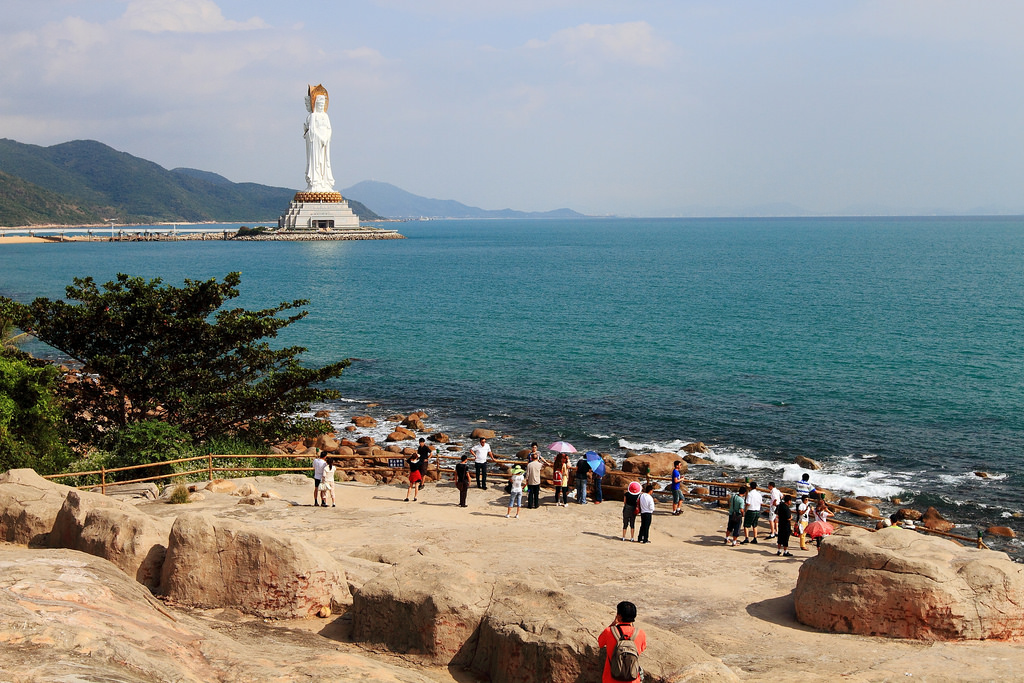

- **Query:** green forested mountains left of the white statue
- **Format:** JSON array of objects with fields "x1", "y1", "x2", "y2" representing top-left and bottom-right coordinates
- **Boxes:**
[{"x1": 0, "y1": 138, "x2": 380, "y2": 225}]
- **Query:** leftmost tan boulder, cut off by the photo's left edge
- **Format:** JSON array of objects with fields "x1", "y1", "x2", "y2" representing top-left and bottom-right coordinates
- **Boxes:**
[{"x1": 0, "y1": 469, "x2": 75, "y2": 546}]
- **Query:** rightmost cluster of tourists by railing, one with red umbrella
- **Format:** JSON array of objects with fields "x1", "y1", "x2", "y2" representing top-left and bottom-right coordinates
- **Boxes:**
[{"x1": 725, "y1": 474, "x2": 835, "y2": 557}]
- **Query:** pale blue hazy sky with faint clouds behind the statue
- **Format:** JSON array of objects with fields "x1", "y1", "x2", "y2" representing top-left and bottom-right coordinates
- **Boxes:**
[{"x1": 0, "y1": 0, "x2": 1024, "y2": 216}]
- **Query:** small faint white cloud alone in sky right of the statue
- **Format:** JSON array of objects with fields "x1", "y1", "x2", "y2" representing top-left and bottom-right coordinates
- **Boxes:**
[{"x1": 526, "y1": 22, "x2": 672, "y2": 67}]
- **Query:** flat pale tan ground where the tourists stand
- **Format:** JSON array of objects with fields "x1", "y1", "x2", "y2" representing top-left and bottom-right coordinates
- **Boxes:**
[{"x1": 139, "y1": 477, "x2": 1024, "y2": 682}]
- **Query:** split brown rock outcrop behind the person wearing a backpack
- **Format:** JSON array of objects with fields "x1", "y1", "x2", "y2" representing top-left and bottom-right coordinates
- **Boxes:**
[{"x1": 351, "y1": 557, "x2": 738, "y2": 683}]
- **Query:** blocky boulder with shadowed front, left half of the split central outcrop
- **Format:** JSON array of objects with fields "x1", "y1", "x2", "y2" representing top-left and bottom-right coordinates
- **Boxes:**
[{"x1": 350, "y1": 557, "x2": 494, "y2": 666}]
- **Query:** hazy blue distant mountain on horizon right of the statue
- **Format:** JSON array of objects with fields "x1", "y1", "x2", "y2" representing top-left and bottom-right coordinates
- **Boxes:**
[{"x1": 341, "y1": 180, "x2": 585, "y2": 218}]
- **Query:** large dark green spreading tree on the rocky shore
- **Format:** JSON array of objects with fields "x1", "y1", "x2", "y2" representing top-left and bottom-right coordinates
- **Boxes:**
[{"x1": 7, "y1": 272, "x2": 349, "y2": 440}]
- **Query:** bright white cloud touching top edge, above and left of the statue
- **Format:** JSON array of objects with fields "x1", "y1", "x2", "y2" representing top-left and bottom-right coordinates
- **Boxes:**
[{"x1": 118, "y1": 0, "x2": 266, "y2": 33}]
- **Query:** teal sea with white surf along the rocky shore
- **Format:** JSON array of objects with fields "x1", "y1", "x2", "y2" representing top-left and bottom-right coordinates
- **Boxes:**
[{"x1": 0, "y1": 217, "x2": 1024, "y2": 555}]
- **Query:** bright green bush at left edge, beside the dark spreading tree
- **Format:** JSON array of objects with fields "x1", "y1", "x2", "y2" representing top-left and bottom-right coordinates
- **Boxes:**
[{"x1": 0, "y1": 354, "x2": 70, "y2": 474}]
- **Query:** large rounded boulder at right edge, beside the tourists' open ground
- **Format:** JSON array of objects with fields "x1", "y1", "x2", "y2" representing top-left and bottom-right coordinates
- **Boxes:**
[{"x1": 794, "y1": 526, "x2": 1024, "y2": 640}]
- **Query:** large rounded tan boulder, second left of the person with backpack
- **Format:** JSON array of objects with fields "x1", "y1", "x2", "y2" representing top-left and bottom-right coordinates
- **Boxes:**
[{"x1": 160, "y1": 512, "x2": 350, "y2": 618}]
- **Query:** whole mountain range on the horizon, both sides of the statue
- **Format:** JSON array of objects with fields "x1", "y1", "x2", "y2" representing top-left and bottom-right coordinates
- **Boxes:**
[{"x1": 0, "y1": 138, "x2": 582, "y2": 226}]
